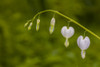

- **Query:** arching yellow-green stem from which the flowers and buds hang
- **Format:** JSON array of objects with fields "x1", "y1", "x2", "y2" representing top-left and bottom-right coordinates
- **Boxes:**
[{"x1": 32, "y1": 10, "x2": 100, "y2": 40}]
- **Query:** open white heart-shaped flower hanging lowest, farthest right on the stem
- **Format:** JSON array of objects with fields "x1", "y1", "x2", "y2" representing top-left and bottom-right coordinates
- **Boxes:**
[{"x1": 77, "y1": 36, "x2": 90, "y2": 59}]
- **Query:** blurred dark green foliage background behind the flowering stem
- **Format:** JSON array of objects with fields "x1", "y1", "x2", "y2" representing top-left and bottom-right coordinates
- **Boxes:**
[{"x1": 0, "y1": 0, "x2": 100, "y2": 67}]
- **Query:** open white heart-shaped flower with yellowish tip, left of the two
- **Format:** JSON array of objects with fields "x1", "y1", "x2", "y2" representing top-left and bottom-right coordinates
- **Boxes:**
[{"x1": 61, "y1": 26, "x2": 75, "y2": 47}]
